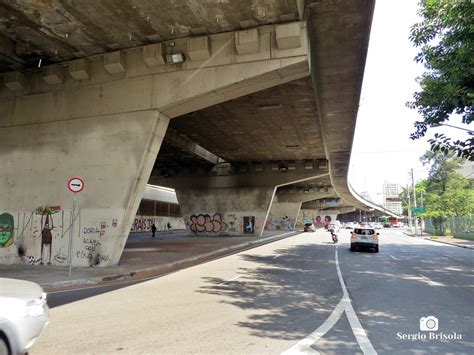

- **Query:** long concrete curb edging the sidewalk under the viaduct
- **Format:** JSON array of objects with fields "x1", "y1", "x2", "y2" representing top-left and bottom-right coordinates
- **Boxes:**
[{"x1": 40, "y1": 231, "x2": 300, "y2": 292}]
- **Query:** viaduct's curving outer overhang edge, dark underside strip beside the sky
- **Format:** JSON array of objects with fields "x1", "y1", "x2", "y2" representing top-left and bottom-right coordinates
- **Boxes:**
[{"x1": 306, "y1": 0, "x2": 375, "y2": 208}]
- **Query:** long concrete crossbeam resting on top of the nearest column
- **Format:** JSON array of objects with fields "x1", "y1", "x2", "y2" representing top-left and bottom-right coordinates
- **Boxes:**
[{"x1": 0, "y1": 22, "x2": 310, "y2": 127}]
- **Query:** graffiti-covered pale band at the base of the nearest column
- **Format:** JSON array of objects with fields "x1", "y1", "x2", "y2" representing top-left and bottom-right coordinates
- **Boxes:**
[{"x1": 0, "y1": 205, "x2": 118, "y2": 266}]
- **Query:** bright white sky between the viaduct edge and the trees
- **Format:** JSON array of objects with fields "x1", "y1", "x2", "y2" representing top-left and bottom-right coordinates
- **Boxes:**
[{"x1": 349, "y1": 0, "x2": 470, "y2": 202}]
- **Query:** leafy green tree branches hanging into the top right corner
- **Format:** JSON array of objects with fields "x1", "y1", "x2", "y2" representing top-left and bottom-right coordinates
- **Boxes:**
[{"x1": 407, "y1": 0, "x2": 474, "y2": 160}]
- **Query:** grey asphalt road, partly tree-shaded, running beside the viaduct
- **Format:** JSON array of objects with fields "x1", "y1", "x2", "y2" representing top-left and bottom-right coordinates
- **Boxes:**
[{"x1": 31, "y1": 230, "x2": 474, "y2": 354}]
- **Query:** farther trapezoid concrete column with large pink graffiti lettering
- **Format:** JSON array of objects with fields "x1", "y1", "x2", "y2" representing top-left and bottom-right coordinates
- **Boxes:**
[{"x1": 176, "y1": 187, "x2": 275, "y2": 236}]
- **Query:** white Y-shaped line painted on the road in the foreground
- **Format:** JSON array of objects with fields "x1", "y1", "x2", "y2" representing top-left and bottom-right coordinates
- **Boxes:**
[{"x1": 282, "y1": 247, "x2": 377, "y2": 355}]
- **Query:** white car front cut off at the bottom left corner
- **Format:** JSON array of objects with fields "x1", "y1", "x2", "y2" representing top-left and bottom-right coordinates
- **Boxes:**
[{"x1": 0, "y1": 278, "x2": 49, "y2": 355}]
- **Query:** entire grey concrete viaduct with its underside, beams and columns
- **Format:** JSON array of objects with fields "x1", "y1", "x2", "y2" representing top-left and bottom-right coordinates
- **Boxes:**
[{"x1": 0, "y1": 0, "x2": 374, "y2": 266}]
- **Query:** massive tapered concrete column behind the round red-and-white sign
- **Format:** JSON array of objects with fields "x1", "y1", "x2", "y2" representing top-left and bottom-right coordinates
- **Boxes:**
[{"x1": 0, "y1": 110, "x2": 169, "y2": 266}]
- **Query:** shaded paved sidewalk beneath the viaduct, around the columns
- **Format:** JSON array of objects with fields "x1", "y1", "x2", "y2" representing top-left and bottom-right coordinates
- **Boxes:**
[{"x1": 0, "y1": 231, "x2": 298, "y2": 291}]
